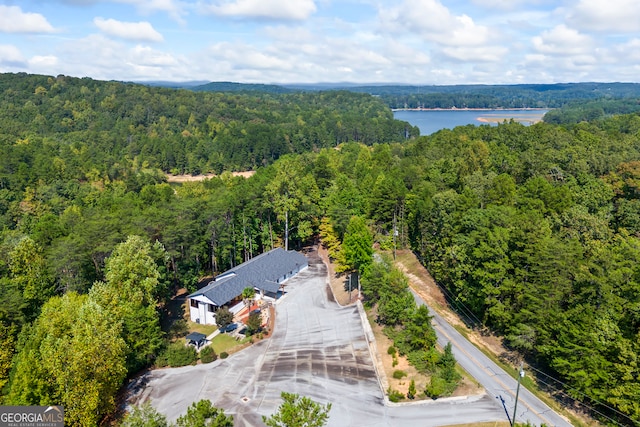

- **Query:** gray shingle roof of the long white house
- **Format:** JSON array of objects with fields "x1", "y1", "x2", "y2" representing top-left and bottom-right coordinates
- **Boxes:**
[{"x1": 189, "y1": 248, "x2": 308, "y2": 307}]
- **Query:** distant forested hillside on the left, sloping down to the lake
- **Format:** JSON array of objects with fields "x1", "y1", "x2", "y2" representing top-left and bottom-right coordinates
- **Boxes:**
[{"x1": 0, "y1": 74, "x2": 418, "y2": 182}]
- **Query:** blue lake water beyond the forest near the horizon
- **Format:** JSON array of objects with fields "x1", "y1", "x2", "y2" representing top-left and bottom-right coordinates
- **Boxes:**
[{"x1": 393, "y1": 110, "x2": 549, "y2": 135}]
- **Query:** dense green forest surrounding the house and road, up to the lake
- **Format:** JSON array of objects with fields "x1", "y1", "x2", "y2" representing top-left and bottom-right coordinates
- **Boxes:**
[{"x1": 0, "y1": 75, "x2": 640, "y2": 425}]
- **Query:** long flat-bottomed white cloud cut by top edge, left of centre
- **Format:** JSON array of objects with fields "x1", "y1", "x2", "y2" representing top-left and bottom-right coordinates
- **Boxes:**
[{"x1": 205, "y1": 0, "x2": 316, "y2": 21}]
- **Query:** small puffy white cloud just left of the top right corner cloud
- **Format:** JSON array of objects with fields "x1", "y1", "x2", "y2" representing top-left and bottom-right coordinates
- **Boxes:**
[{"x1": 532, "y1": 25, "x2": 594, "y2": 56}]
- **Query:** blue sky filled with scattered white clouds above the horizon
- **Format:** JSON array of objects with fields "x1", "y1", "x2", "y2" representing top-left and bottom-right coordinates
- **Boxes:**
[{"x1": 0, "y1": 0, "x2": 640, "y2": 85}]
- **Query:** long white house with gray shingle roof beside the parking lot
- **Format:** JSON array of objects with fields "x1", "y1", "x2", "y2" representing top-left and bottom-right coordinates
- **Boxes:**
[{"x1": 187, "y1": 248, "x2": 309, "y2": 325}]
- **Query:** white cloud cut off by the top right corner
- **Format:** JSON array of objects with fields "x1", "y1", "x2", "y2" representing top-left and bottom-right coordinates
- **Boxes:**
[{"x1": 567, "y1": 0, "x2": 640, "y2": 33}]
